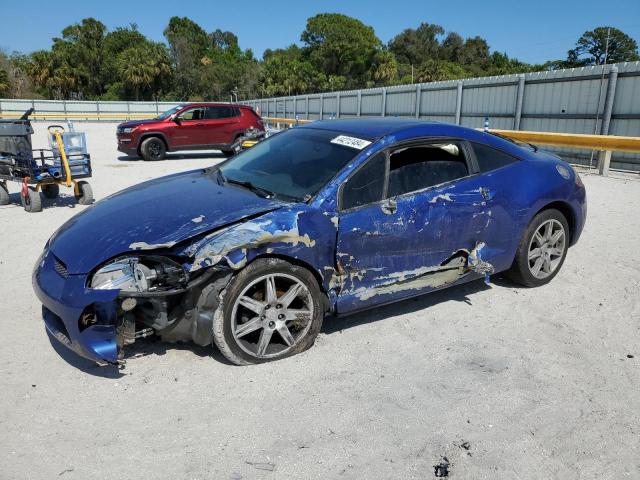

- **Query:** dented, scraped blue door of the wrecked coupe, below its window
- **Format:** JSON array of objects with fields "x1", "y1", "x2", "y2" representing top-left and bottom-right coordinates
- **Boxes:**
[{"x1": 336, "y1": 171, "x2": 513, "y2": 313}]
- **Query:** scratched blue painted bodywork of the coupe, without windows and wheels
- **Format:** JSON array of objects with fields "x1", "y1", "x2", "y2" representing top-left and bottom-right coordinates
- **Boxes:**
[{"x1": 33, "y1": 118, "x2": 586, "y2": 362}]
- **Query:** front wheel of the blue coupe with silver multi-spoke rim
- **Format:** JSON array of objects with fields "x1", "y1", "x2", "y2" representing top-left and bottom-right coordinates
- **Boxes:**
[{"x1": 213, "y1": 258, "x2": 324, "y2": 365}]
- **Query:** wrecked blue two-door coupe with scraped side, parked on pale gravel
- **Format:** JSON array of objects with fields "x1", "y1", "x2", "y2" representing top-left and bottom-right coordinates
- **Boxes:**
[{"x1": 33, "y1": 119, "x2": 586, "y2": 365}]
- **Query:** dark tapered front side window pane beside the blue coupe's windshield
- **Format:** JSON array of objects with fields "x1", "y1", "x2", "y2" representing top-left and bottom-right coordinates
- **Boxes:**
[{"x1": 340, "y1": 152, "x2": 387, "y2": 210}]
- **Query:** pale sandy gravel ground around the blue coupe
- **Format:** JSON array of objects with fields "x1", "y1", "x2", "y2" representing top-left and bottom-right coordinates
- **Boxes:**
[{"x1": 0, "y1": 123, "x2": 640, "y2": 480}]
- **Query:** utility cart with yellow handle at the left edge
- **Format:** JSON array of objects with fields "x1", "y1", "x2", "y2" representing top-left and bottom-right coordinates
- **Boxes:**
[{"x1": 0, "y1": 109, "x2": 93, "y2": 212}]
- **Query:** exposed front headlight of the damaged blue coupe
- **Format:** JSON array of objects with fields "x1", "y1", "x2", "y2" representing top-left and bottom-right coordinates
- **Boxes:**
[{"x1": 90, "y1": 256, "x2": 187, "y2": 293}]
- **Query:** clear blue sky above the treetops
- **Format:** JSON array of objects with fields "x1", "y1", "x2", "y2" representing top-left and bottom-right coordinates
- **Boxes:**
[{"x1": 0, "y1": 0, "x2": 640, "y2": 63}]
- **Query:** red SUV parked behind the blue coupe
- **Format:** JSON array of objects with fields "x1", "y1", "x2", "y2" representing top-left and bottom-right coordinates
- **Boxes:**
[{"x1": 116, "y1": 103, "x2": 264, "y2": 160}]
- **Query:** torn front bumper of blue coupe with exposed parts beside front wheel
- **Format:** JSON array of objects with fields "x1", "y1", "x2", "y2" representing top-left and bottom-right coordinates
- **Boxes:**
[{"x1": 33, "y1": 250, "x2": 230, "y2": 365}]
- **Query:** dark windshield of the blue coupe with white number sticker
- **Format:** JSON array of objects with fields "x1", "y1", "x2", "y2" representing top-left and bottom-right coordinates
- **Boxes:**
[{"x1": 220, "y1": 128, "x2": 369, "y2": 201}]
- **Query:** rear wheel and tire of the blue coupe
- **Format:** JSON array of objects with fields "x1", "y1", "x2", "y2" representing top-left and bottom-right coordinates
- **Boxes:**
[{"x1": 505, "y1": 208, "x2": 570, "y2": 287}]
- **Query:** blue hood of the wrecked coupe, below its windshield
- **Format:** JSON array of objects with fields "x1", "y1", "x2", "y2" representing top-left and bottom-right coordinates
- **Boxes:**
[{"x1": 49, "y1": 170, "x2": 285, "y2": 274}]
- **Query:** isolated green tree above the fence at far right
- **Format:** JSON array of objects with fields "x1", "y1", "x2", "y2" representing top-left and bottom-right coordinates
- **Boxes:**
[{"x1": 566, "y1": 27, "x2": 640, "y2": 66}]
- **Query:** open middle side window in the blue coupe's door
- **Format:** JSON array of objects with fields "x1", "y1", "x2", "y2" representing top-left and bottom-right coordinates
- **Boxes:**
[{"x1": 387, "y1": 142, "x2": 469, "y2": 197}]
